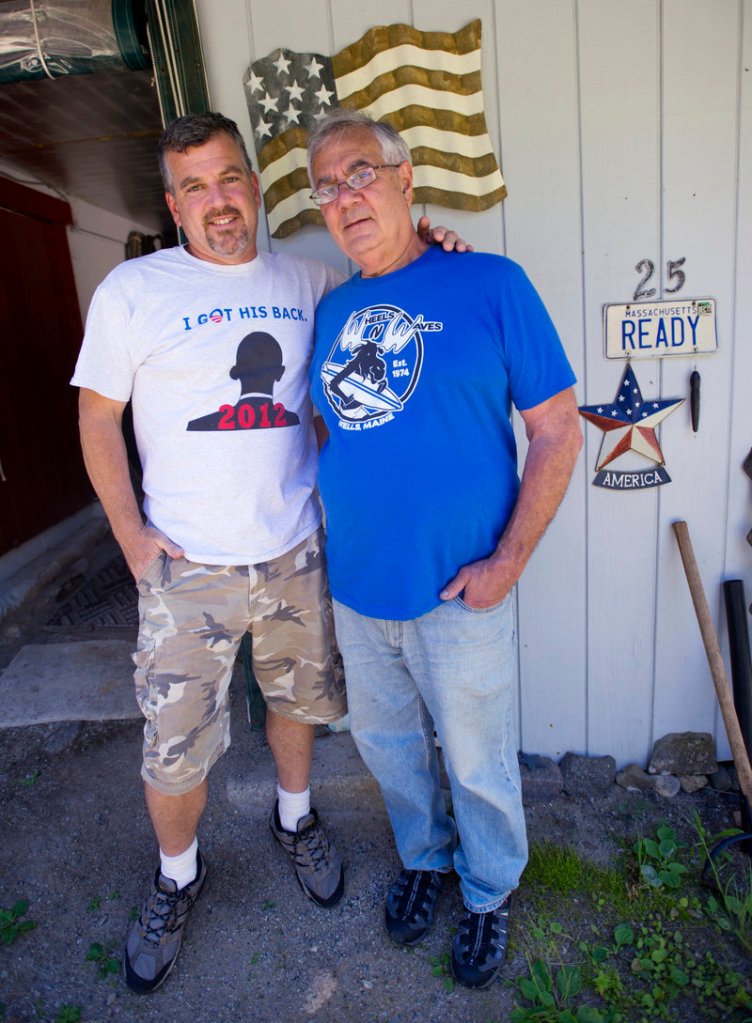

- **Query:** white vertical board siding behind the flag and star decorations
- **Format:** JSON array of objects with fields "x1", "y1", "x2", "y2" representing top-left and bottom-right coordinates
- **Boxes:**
[{"x1": 196, "y1": 0, "x2": 752, "y2": 765}]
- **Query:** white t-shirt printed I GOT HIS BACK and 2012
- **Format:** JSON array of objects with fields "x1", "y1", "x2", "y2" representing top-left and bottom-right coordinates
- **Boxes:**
[{"x1": 72, "y1": 248, "x2": 342, "y2": 565}]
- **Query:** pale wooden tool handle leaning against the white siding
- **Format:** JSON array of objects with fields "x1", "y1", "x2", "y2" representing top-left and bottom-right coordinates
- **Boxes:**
[{"x1": 673, "y1": 522, "x2": 752, "y2": 805}]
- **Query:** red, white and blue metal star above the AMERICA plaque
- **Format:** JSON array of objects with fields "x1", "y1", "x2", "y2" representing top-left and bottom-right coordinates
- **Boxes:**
[{"x1": 579, "y1": 362, "x2": 684, "y2": 470}]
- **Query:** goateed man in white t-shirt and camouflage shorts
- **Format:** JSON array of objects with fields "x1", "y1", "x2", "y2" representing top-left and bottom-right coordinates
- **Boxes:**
[{"x1": 73, "y1": 114, "x2": 347, "y2": 992}]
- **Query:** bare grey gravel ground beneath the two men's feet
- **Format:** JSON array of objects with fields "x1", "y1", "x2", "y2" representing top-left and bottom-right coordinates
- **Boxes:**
[{"x1": 0, "y1": 698, "x2": 515, "y2": 1023}]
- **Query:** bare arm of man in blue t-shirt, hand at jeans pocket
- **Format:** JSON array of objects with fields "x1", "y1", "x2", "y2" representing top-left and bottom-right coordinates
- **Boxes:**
[{"x1": 440, "y1": 388, "x2": 582, "y2": 608}]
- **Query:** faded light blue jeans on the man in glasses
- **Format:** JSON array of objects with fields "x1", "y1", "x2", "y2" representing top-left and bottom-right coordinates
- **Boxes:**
[{"x1": 334, "y1": 596, "x2": 527, "y2": 913}]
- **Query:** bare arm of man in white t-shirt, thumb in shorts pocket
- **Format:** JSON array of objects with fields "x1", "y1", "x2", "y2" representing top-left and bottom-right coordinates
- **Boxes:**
[{"x1": 79, "y1": 388, "x2": 183, "y2": 580}]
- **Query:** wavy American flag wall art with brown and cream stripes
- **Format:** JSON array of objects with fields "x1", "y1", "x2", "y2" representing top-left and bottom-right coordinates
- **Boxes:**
[{"x1": 244, "y1": 19, "x2": 506, "y2": 238}]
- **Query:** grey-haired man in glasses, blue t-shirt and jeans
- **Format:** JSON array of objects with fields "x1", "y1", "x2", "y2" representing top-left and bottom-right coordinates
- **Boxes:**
[{"x1": 309, "y1": 110, "x2": 582, "y2": 987}]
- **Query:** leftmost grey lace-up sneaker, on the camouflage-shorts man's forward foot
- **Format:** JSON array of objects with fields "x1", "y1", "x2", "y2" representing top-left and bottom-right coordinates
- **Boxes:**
[{"x1": 123, "y1": 852, "x2": 207, "y2": 994}]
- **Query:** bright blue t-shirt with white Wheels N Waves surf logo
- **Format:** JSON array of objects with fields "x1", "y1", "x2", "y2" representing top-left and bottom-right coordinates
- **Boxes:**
[{"x1": 310, "y1": 247, "x2": 575, "y2": 621}]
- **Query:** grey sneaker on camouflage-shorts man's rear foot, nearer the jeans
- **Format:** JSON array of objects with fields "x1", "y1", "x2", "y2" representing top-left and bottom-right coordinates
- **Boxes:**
[{"x1": 269, "y1": 800, "x2": 345, "y2": 909}]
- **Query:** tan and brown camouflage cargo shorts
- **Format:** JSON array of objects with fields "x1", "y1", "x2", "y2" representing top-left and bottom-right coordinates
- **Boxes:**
[{"x1": 133, "y1": 530, "x2": 347, "y2": 795}]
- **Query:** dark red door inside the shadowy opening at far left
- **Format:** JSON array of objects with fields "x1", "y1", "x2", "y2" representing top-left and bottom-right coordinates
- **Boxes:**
[{"x1": 0, "y1": 178, "x2": 93, "y2": 554}]
